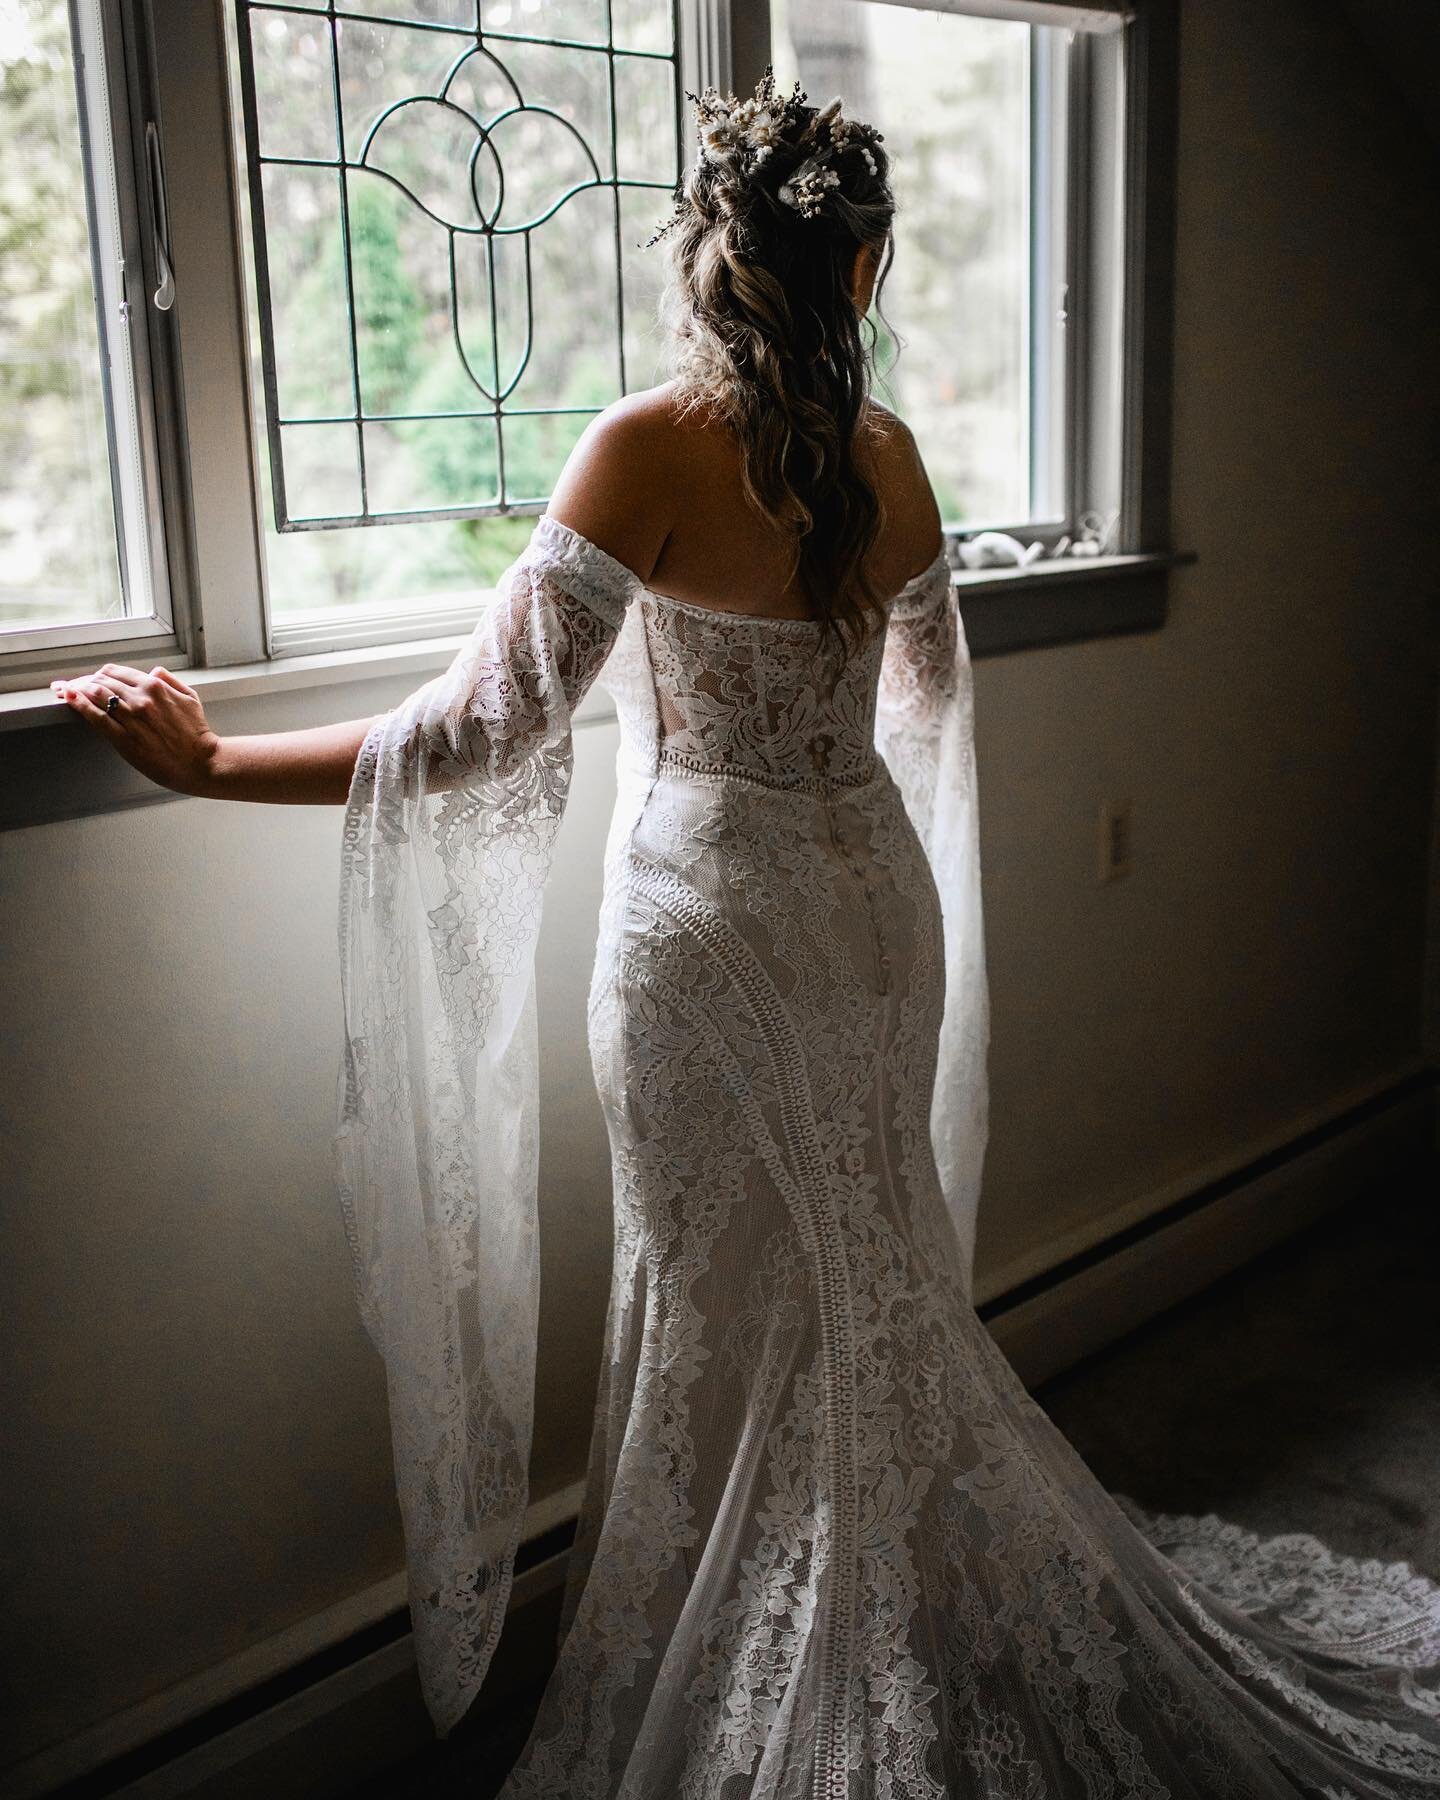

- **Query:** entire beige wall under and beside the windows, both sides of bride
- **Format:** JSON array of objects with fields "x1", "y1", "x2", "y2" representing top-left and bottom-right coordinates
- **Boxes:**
[{"x1": 0, "y1": 0, "x2": 1440, "y2": 1753}]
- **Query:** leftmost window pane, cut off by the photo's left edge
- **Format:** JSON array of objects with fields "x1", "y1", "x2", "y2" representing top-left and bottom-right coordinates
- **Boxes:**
[{"x1": 0, "y1": 0, "x2": 171, "y2": 653}]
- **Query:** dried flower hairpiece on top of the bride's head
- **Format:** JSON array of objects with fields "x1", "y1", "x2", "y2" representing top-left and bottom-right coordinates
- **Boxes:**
[{"x1": 643, "y1": 67, "x2": 884, "y2": 250}]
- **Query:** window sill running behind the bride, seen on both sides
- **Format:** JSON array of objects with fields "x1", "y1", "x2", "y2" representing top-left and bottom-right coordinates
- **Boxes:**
[{"x1": 0, "y1": 553, "x2": 1195, "y2": 832}]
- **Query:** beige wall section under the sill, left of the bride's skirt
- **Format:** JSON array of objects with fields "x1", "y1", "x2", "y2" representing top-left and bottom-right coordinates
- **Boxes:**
[{"x1": 0, "y1": 705, "x2": 616, "y2": 1786}]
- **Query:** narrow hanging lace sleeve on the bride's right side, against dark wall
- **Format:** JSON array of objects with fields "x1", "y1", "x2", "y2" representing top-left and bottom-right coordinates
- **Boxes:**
[{"x1": 875, "y1": 554, "x2": 990, "y2": 1282}]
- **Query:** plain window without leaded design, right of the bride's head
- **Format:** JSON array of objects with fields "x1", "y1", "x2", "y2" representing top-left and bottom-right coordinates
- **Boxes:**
[{"x1": 770, "y1": 0, "x2": 1121, "y2": 547}]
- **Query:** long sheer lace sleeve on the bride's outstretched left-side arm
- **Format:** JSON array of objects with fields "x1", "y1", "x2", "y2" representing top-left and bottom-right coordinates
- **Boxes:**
[{"x1": 335, "y1": 515, "x2": 639, "y2": 1737}]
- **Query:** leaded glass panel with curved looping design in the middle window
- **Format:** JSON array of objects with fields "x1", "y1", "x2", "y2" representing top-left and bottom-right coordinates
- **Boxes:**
[{"x1": 236, "y1": 0, "x2": 682, "y2": 531}]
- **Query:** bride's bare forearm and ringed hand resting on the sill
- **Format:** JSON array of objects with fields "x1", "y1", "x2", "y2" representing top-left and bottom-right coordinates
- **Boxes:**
[{"x1": 50, "y1": 662, "x2": 374, "y2": 806}]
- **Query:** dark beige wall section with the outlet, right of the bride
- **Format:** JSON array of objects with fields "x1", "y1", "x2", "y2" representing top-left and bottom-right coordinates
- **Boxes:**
[{"x1": 977, "y1": 0, "x2": 1440, "y2": 1271}]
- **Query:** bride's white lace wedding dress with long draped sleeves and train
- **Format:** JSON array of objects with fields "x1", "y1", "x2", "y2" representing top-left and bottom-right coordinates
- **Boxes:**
[{"x1": 337, "y1": 517, "x2": 1440, "y2": 1800}]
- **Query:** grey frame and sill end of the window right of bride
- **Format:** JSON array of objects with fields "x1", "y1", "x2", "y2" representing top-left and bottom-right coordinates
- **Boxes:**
[{"x1": 733, "y1": 0, "x2": 1195, "y2": 622}]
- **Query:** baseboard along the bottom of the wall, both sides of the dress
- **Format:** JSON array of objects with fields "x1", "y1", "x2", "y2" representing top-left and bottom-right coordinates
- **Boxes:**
[{"x1": 0, "y1": 1069, "x2": 1436, "y2": 1800}]
